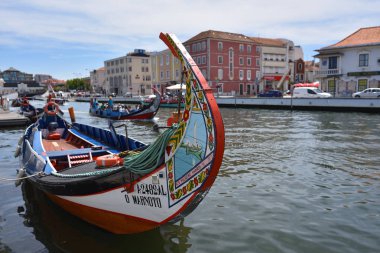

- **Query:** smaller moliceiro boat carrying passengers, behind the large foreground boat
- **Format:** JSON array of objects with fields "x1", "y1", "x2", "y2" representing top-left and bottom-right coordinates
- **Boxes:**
[{"x1": 90, "y1": 89, "x2": 161, "y2": 120}]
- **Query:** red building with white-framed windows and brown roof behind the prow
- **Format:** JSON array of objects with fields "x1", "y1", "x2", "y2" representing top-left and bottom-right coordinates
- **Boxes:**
[{"x1": 184, "y1": 30, "x2": 260, "y2": 96}]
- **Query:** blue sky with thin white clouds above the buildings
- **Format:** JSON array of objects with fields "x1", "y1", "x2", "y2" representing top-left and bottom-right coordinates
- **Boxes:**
[{"x1": 0, "y1": 0, "x2": 380, "y2": 80}]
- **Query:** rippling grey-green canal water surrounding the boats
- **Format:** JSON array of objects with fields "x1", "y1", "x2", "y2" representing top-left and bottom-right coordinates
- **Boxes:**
[{"x1": 0, "y1": 102, "x2": 380, "y2": 253}]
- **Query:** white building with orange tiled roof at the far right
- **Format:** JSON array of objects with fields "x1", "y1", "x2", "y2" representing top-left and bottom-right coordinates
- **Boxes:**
[{"x1": 315, "y1": 26, "x2": 380, "y2": 96}]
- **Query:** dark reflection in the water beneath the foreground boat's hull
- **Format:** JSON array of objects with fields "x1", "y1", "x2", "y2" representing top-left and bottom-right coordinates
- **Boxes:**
[{"x1": 17, "y1": 182, "x2": 191, "y2": 253}]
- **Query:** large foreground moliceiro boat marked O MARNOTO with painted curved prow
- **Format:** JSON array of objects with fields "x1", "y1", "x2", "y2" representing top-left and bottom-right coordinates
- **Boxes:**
[{"x1": 20, "y1": 33, "x2": 224, "y2": 234}]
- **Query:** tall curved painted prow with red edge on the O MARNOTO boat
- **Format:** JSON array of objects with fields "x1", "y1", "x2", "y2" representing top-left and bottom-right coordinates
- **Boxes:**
[{"x1": 160, "y1": 33, "x2": 224, "y2": 213}]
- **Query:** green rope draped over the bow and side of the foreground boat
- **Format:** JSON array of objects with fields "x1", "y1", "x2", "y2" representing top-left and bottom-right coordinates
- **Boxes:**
[{"x1": 51, "y1": 124, "x2": 178, "y2": 178}]
